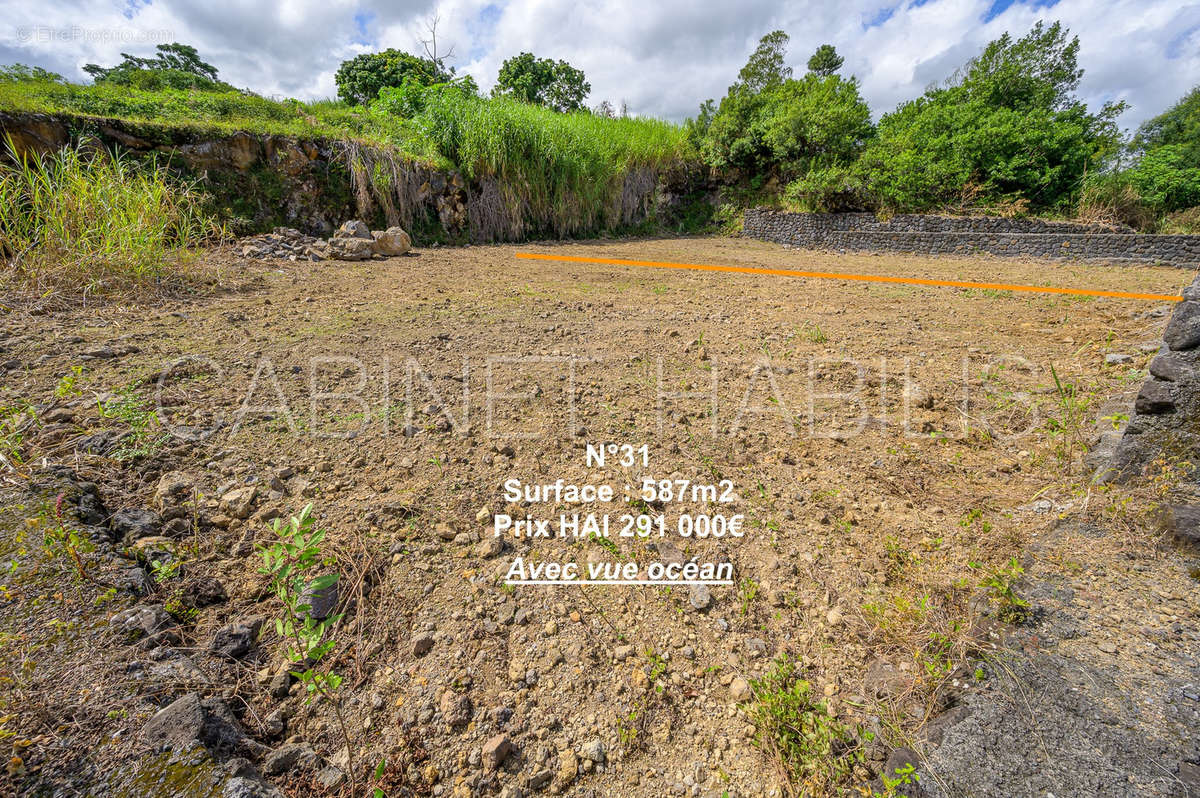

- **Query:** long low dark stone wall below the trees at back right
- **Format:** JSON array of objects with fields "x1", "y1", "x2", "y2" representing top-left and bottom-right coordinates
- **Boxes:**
[{"x1": 743, "y1": 208, "x2": 1200, "y2": 268}]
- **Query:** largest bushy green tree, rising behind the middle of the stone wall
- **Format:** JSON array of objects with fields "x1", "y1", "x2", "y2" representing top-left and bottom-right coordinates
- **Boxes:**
[{"x1": 856, "y1": 22, "x2": 1124, "y2": 210}]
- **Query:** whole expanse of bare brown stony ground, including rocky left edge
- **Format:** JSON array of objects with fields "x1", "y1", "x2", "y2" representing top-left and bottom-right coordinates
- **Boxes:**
[{"x1": 0, "y1": 238, "x2": 1200, "y2": 797}]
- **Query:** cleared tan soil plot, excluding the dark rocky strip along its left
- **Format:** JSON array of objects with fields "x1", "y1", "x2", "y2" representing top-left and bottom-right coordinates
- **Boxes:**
[{"x1": 0, "y1": 239, "x2": 1190, "y2": 796}]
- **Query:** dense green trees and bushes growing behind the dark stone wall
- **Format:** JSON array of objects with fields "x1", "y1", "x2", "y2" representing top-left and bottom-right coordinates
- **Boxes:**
[{"x1": 686, "y1": 22, "x2": 1200, "y2": 226}]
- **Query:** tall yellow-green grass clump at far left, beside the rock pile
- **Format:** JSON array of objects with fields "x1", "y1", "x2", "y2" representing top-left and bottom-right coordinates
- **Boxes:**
[{"x1": 0, "y1": 139, "x2": 223, "y2": 294}]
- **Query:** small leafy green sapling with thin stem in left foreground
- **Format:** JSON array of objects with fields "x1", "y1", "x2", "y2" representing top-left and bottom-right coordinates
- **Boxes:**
[{"x1": 258, "y1": 504, "x2": 356, "y2": 796}]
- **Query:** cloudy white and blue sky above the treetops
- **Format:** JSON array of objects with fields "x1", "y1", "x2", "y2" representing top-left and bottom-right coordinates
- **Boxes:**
[{"x1": 0, "y1": 0, "x2": 1200, "y2": 128}]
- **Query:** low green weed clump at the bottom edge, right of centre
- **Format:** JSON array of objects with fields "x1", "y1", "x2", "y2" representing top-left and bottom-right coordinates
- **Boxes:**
[{"x1": 749, "y1": 656, "x2": 872, "y2": 796}]
